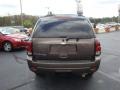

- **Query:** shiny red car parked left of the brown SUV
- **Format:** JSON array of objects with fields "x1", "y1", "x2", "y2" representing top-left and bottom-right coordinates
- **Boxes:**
[{"x1": 0, "y1": 27, "x2": 28, "y2": 52}]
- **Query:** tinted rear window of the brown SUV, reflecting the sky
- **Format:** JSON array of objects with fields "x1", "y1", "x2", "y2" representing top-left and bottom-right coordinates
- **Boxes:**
[{"x1": 33, "y1": 19, "x2": 94, "y2": 38}]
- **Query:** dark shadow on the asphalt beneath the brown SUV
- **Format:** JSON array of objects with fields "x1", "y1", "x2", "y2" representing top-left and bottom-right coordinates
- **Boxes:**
[{"x1": 34, "y1": 73, "x2": 93, "y2": 90}]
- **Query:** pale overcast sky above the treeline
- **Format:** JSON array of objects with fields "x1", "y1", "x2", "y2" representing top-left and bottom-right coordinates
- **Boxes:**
[{"x1": 0, "y1": 0, "x2": 120, "y2": 18}]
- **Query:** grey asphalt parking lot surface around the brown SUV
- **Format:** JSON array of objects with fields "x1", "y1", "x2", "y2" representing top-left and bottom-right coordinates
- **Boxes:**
[{"x1": 0, "y1": 31, "x2": 120, "y2": 90}]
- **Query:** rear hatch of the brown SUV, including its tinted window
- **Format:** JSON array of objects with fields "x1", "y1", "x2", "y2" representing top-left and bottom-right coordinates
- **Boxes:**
[{"x1": 32, "y1": 18, "x2": 95, "y2": 60}]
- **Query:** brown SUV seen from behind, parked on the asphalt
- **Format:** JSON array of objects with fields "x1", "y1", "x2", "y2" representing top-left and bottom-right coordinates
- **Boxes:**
[{"x1": 27, "y1": 15, "x2": 101, "y2": 76}]
